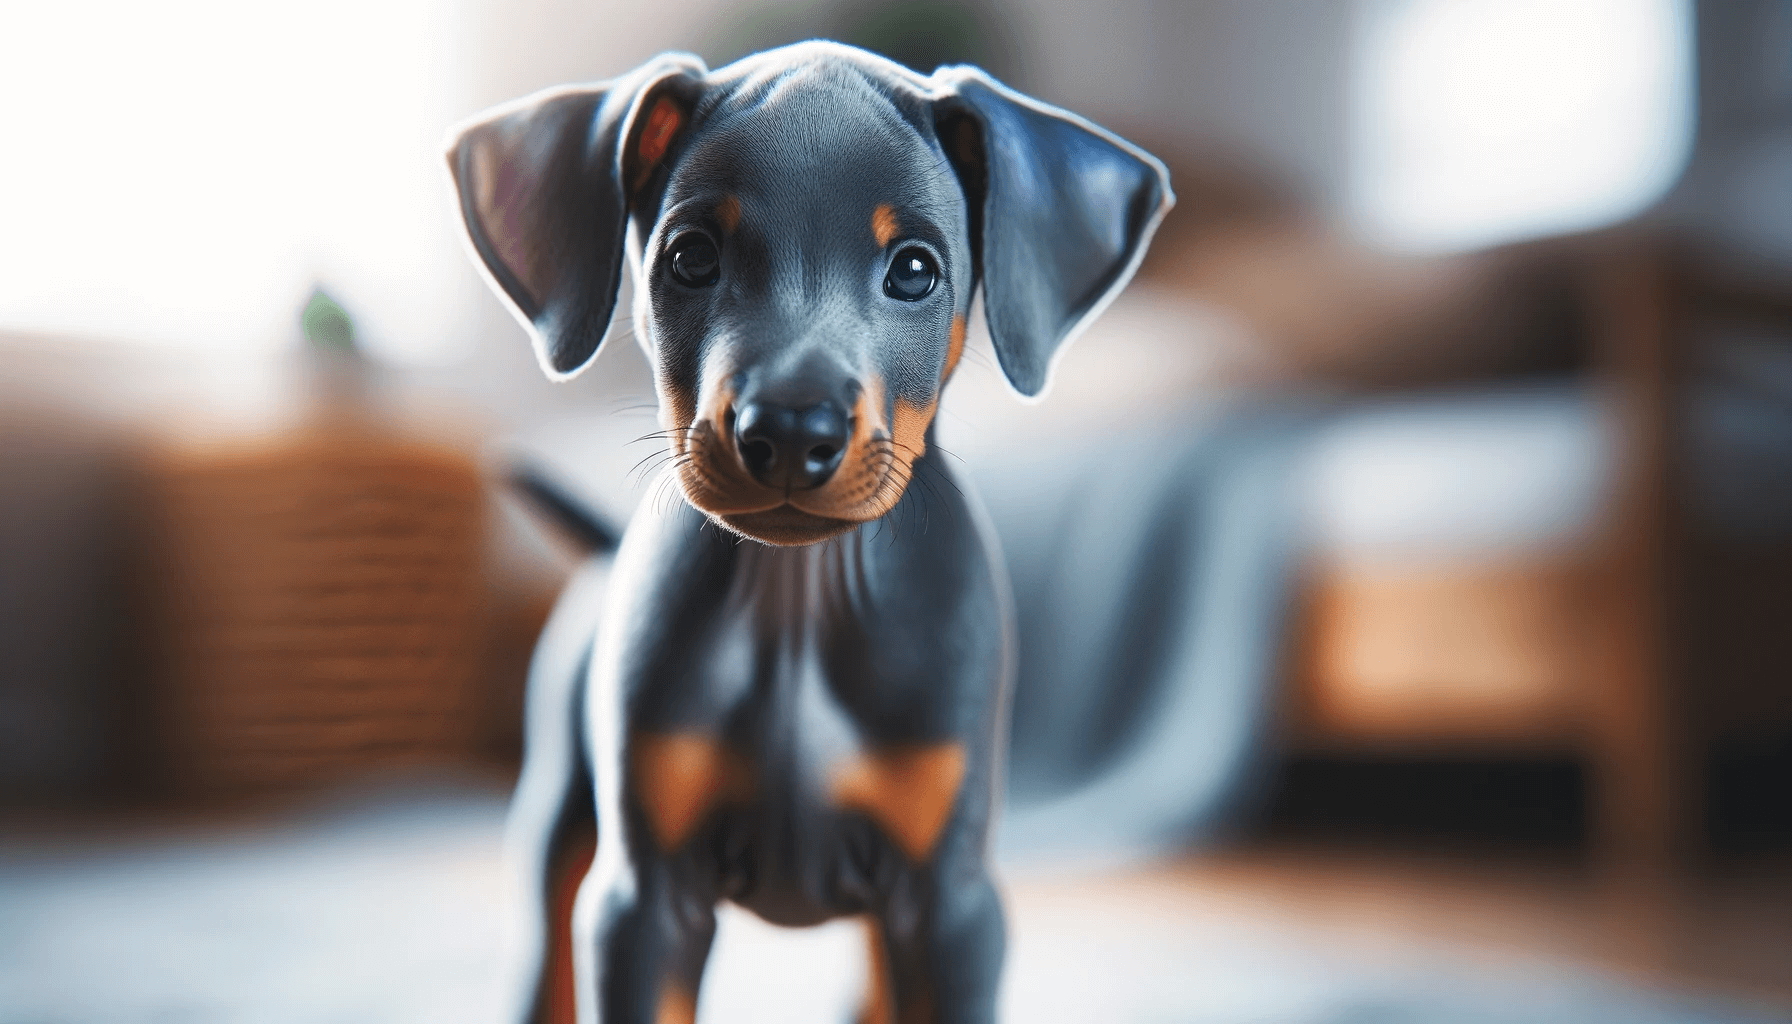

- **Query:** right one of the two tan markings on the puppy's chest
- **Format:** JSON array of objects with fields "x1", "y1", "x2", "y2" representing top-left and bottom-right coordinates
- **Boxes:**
[{"x1": 830, "y1": 742, "x2": 964, "y2": 864}]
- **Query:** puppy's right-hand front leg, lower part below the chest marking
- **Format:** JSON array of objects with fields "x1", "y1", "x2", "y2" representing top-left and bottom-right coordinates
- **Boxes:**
[{"x1": 866, "y1": 866, "x2": 1005, "y2": 1024}]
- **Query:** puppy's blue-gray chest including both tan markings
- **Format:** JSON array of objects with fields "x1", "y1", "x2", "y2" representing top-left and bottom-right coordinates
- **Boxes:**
[{"x1": 631, "y1": 552, "x2": 968, "y2": 861}]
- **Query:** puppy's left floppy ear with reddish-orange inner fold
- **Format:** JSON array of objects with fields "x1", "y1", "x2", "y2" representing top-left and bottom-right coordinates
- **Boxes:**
[{"x1": 448, "y1": 54, "x2": 706, "y2": 380}]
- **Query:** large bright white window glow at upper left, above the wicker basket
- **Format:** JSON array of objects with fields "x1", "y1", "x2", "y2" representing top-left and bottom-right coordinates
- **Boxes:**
[{"x1": 0, "y1": 0, "x2": 470, "y2": 360}]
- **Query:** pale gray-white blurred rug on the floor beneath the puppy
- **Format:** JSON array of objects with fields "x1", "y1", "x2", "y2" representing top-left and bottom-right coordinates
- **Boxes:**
[{"x1": 0, "y1": 791, "x2": 1776, "y2": 1024}]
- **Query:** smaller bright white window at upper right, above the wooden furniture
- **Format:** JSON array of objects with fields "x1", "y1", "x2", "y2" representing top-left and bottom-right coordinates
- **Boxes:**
[{"x1": 1349, "y1": 0, "x2": 1693, "y2": 251}]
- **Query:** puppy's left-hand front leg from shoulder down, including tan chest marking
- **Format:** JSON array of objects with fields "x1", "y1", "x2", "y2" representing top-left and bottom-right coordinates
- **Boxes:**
[{"x1": 573, "y1": 502, "x2": 747, "y2": 1024}]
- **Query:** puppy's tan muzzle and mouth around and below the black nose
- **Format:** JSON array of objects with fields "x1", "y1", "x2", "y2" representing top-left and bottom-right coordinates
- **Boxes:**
[{"x1": 670, "y1": 387, "x2": 935, "y2": 547}]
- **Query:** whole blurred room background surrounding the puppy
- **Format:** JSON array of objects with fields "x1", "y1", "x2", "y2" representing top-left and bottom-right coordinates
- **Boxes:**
[{"x1": 0, "y1": 0, "x2": 1792, "y2": 1024}]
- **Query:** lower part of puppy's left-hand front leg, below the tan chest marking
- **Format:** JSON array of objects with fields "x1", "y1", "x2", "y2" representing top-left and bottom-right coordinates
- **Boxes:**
[{"x1": 573, "y1": 861, "x2": 715, "y2": 1024}]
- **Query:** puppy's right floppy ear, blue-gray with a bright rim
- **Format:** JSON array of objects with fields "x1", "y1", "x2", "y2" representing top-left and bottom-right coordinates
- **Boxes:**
[{"x1": 932, "y1": 66, "x2": 1176, "y2": 398}]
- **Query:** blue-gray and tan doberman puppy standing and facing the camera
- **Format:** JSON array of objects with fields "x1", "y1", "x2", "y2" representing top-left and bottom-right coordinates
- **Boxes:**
[{"x1": 450, "y1": 43, "x2": 1174, "y2": 1024}]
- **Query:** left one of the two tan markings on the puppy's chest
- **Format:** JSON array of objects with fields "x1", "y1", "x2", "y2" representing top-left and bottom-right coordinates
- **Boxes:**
[{"x1": 629, "y1": 733, "x2": 753, "y2": 854}]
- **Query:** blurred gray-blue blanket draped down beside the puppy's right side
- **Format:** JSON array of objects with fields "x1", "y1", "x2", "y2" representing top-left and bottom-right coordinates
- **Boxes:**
[{"x1": 971, "y1": 409, "x2": 1310, "y2": 857}]
